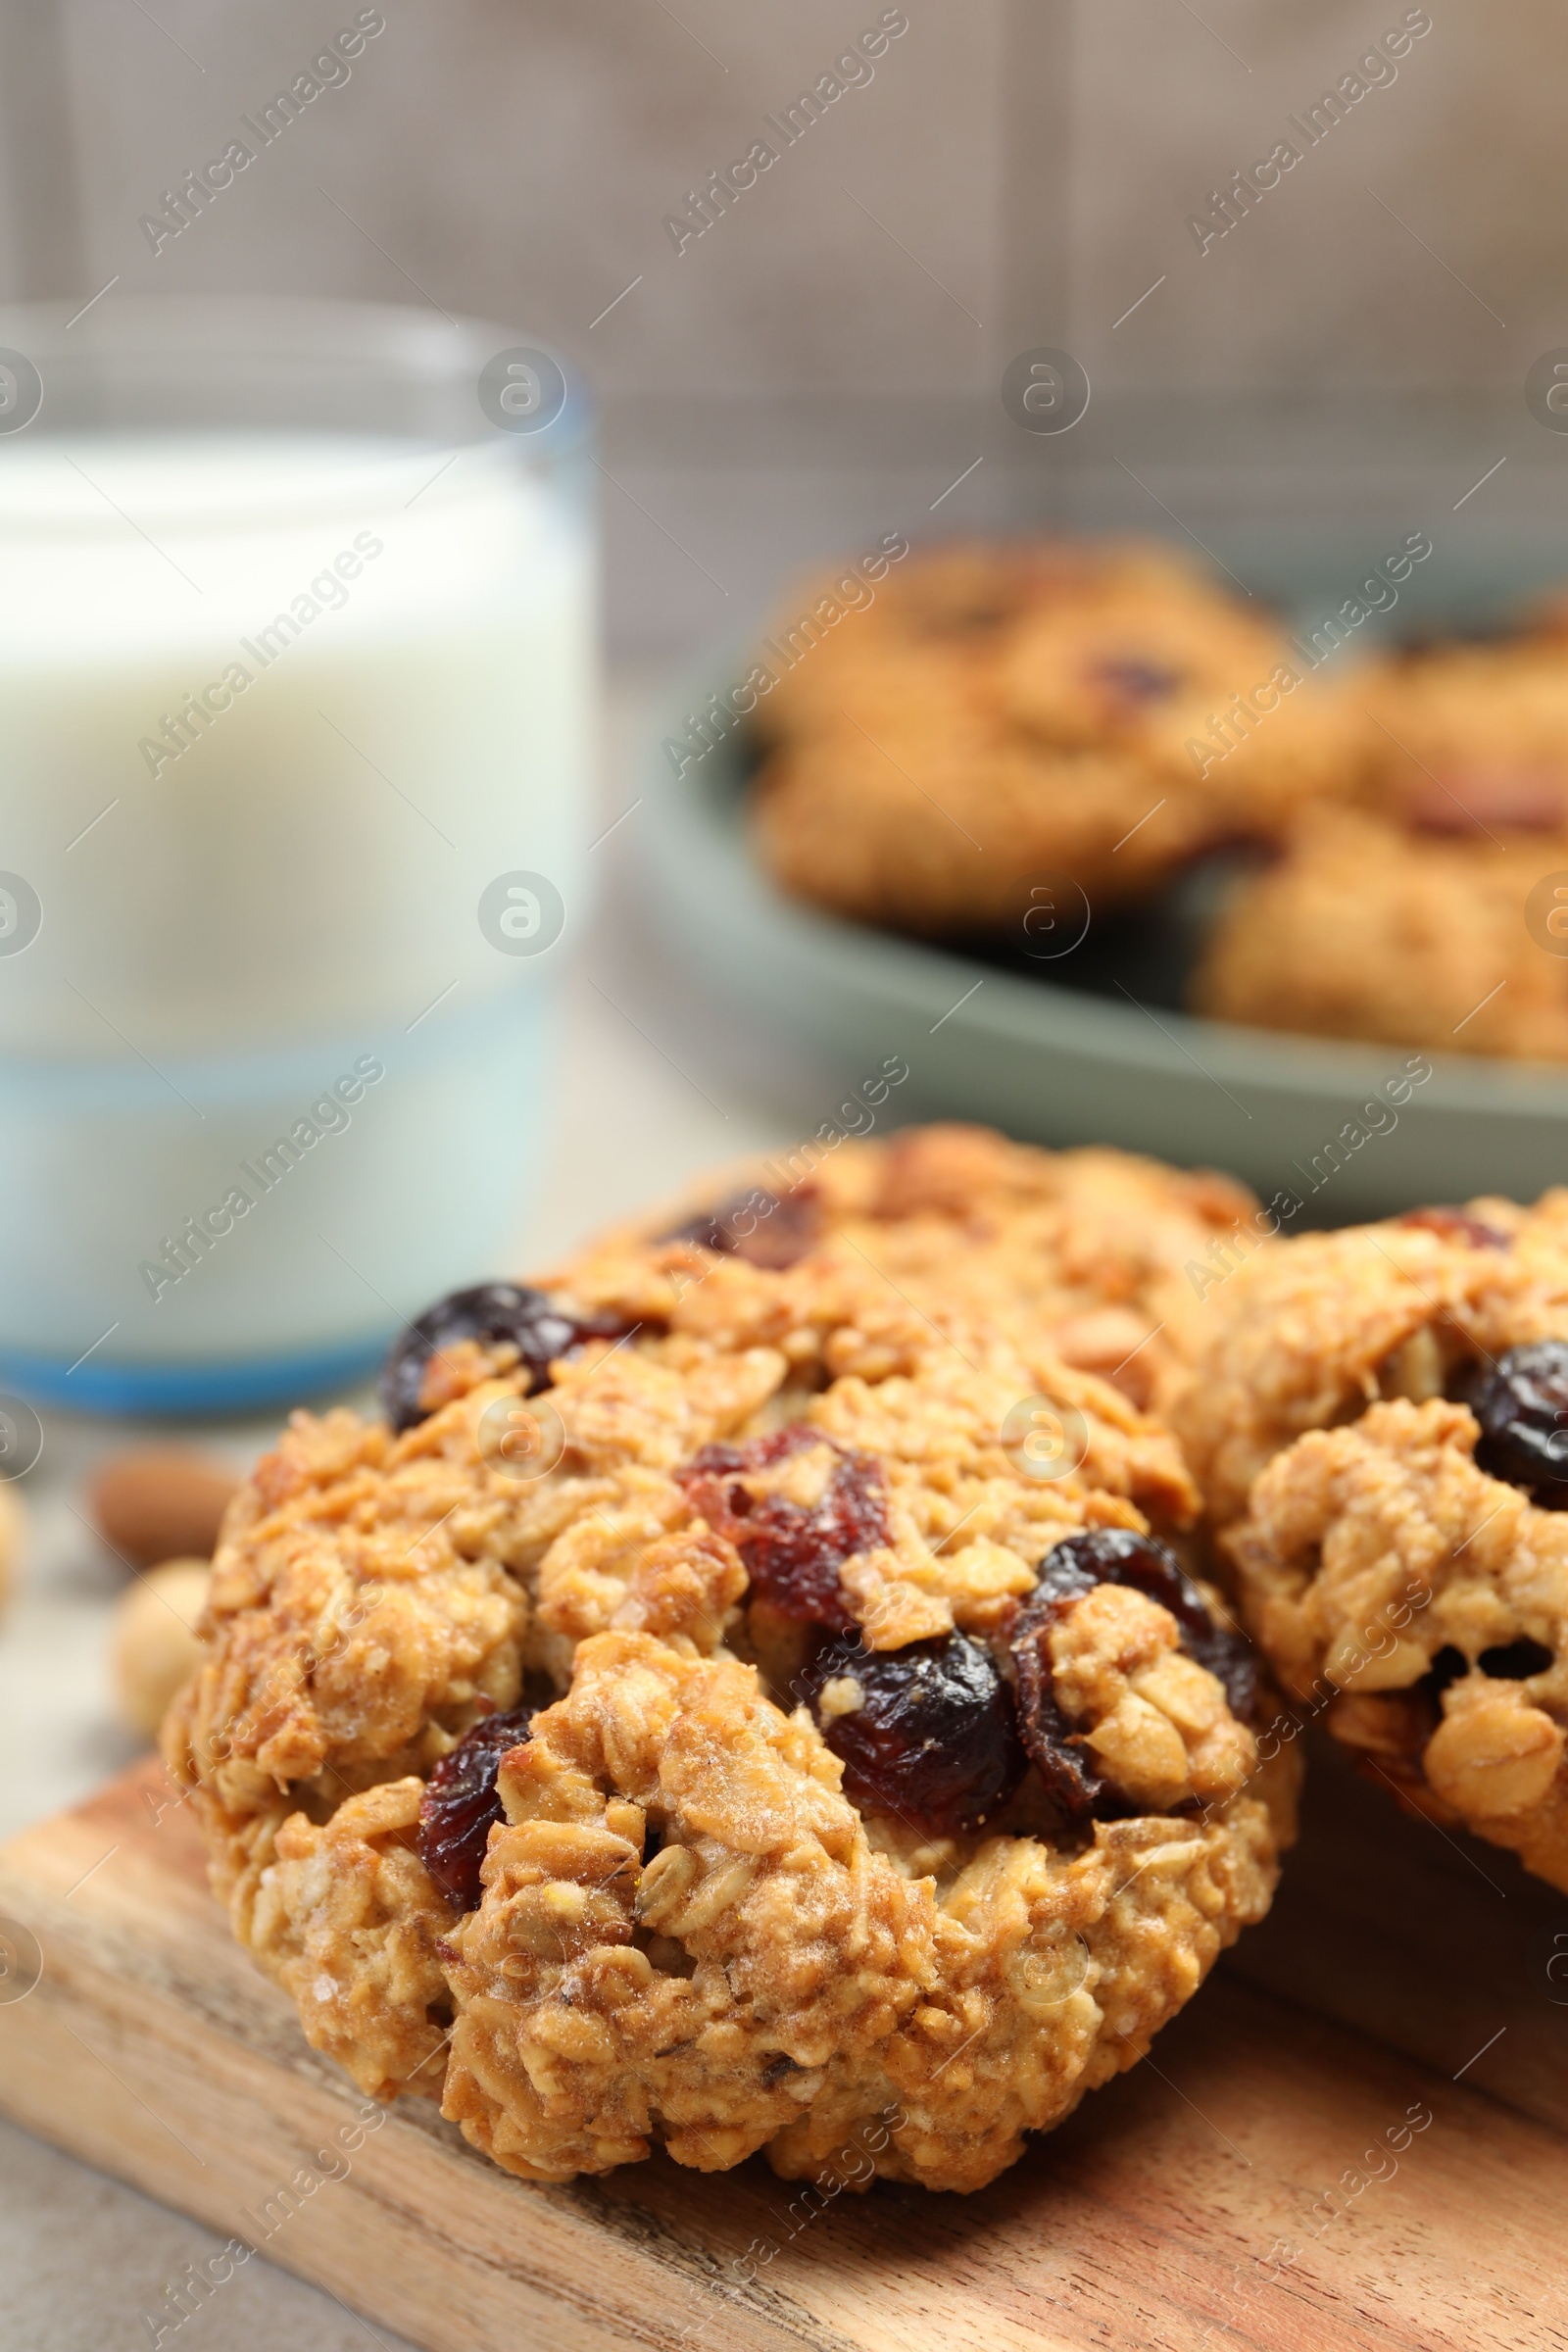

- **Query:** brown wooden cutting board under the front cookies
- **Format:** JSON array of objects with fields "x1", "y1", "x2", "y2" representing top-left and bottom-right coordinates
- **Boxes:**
[{"x1": 0, "y1": 1750, "x2": 1568, "y2": 2352}]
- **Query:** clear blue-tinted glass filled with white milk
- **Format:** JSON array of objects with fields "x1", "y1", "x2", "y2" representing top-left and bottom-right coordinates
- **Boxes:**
[{"x1": 0, "y1": 296, "x2": 595, "y2": 1411}]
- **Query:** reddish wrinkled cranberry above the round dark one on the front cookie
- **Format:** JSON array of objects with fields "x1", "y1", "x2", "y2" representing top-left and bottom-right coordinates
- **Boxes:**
[{"x1": 674, "y1": 1421, "x2": 889, "y2": 1633}]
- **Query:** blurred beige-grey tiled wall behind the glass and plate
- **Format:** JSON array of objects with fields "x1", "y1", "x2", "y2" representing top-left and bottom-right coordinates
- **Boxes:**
[{"x1": 0, "y1": 0, "x2": 1568, "y2": 642}]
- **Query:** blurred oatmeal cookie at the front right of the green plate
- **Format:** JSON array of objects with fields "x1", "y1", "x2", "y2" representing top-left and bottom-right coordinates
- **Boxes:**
[{"x1": 1192, "y1": 808, "x2": 1568, "y2": 1060}]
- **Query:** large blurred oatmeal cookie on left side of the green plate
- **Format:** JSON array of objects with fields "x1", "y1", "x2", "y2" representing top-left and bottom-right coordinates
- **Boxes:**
[{"x1": 757, "y1": 543, "x2": 1363, "y2": 934}]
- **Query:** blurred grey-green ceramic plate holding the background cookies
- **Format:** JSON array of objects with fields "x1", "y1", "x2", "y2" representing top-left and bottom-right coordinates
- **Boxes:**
[{"x1": 644, "y1": 663, "x2": 1568, "y2": 1223}]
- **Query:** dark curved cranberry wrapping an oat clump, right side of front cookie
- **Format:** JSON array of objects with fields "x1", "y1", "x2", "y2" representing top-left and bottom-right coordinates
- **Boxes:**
[{"x1": 1013, "y1": 1527, "x2": 1257, "y2": 1823}]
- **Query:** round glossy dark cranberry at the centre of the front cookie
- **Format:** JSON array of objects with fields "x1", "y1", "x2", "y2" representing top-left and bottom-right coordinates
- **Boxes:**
[{"x1": 802, "y1": 1633, "x2": 1027, "y2": 1835}]
